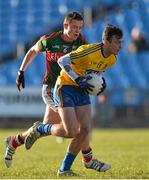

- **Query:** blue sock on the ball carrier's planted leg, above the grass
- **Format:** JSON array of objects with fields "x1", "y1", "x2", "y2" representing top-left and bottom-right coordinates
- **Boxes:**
[{"x1": 60, "y1": 152, "x2": 76, "y2": 171}]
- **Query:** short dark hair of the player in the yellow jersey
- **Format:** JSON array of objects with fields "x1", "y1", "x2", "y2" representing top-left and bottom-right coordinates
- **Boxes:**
[{"x1": 102, "y1": 24, "x2": 123, "y2": 42}]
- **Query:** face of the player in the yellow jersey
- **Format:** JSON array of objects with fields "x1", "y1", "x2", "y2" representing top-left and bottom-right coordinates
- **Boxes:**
[{"x1": 109, "y1": 36, "x2": 122, "y2": 55}]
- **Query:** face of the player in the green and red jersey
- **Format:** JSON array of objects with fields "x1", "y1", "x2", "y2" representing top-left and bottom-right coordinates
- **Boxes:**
[{"x1": 64, "y1": 20, "x2": 83, "y2": 41}]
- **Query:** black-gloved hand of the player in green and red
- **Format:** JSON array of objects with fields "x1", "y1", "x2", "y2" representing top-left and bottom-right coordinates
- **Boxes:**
[{"x1": 16, "y1": 71, "x2": 25, "y2": 91}]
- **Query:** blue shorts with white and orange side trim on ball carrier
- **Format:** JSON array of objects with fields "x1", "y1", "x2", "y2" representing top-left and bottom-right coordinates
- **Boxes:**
[{"x1": 53, "y1": 84, "x2": 91, "y2": 107}]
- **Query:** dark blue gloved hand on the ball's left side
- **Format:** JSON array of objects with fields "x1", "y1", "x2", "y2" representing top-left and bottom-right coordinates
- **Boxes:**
[{"x1": 75, "y1": 76, "x2": 94, "y2": 93}]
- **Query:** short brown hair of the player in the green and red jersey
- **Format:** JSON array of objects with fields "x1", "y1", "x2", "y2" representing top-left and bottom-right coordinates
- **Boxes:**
[{"x1": 64, "y1": 11, "x2": 83, "y2": 23}]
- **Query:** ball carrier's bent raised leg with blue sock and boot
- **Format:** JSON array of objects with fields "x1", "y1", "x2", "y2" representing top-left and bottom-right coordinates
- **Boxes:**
[{"x1": 25, "y1": 107, "x2": 79, "y2": 149}]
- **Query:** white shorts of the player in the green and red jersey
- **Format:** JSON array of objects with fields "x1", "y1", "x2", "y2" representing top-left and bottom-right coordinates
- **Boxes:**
[{"x1": 42, "y1": 84, "x2": 57, "y2": 111}]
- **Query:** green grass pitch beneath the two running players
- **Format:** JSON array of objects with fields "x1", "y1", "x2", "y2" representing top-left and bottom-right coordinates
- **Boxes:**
[{"x1": 0, "y1": 129, "x2": 149, "y2": 179}]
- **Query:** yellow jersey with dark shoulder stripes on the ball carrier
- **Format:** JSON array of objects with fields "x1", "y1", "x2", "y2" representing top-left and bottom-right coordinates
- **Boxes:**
[{"x1": 58, "y1": 43, "x2": 116, "y2": 85}]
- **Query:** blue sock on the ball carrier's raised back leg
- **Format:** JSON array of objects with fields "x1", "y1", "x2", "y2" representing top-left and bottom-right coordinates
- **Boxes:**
[{"x1": 37, "y1": 124, "x2": 52, "y2": 135}]
